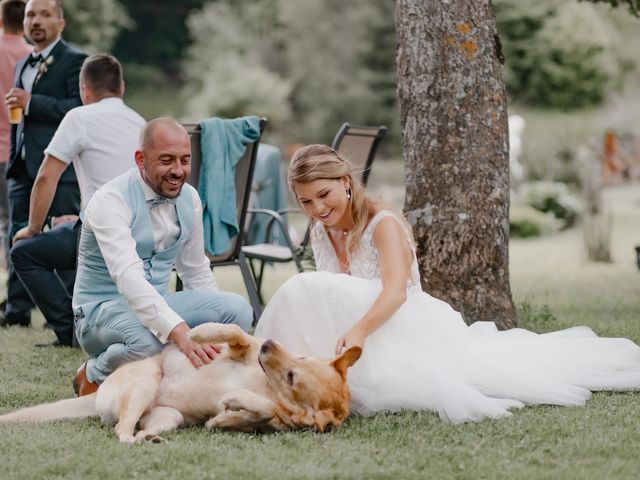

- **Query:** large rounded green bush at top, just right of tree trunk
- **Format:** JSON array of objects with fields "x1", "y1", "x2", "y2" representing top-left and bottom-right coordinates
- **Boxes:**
[{"x1": 493, "y1": 0, "x2": 621, "y2": 109}]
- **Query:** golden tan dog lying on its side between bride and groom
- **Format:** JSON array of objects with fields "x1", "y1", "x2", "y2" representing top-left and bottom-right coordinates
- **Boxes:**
[{"x1": 0, "y1": 323, "x2": 362, "y2": 443}]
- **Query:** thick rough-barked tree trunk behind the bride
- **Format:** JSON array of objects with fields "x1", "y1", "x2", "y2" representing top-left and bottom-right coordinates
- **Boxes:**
[{"x1": 396, "y1": 0, "x2": 517, "y2": 329}]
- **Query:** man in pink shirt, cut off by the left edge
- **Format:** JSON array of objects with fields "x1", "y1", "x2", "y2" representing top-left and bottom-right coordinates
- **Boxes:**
[{"x1": 0, "y1": 0, "x2": 33, "y2": 265}]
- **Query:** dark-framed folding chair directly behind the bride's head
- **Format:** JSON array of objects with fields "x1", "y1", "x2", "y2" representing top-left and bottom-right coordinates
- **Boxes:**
[{"x1": 242, "y1": 122, "x2": 387, "y2": 304}]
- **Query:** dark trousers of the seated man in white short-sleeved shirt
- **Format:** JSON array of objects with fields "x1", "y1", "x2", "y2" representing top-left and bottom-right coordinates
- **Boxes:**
[{"x1": 11, "y1": 221, "x2": 81, "y2": 345}]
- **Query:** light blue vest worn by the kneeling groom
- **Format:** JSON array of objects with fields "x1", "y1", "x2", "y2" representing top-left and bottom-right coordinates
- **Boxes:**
[{"x1": 73, "y1": 168, "x2": 195, "y2": 317}]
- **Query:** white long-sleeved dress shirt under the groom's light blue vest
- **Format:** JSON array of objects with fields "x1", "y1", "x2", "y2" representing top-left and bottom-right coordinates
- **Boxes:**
[{"x1": 83, "y1": 175, "x2": 218, "y2": 343}]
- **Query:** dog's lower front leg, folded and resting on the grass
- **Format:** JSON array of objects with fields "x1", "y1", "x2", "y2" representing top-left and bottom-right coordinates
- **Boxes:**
[{"x1": 205, "y1": 390, "x2": 276, "y2": 431}]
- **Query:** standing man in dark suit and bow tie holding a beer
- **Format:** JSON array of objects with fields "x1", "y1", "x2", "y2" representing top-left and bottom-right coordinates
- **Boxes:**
[{"x1": 0, "y1": 0, "x2": 86, "y2": 346}]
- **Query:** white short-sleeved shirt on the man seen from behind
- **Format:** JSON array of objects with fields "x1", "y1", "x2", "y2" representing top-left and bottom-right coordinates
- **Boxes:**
[{"x1": 44, "y1": 97, "x2": 145, "y2": 208}]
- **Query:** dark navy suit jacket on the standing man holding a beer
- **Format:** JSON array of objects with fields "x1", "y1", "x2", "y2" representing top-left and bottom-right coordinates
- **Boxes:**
[{"x1": 7, "y1": 40, "x2": 86, "y2": 183}]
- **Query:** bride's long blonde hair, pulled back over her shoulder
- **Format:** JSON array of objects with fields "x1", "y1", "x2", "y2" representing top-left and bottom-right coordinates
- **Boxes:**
[{"x1": 287, "y1": 144, "x2": 411, "y2": 256}]
